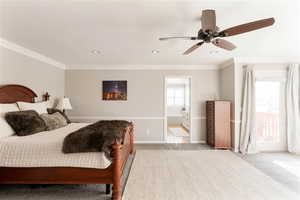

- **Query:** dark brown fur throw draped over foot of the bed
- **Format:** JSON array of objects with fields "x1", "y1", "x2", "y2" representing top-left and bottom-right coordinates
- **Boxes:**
[{"x1": 62, "y1": 120, "x2": 133, "y2": 160}]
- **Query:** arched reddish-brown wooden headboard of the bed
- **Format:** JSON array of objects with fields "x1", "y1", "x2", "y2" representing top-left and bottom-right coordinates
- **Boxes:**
[{"x1": 0, "y1": 85, "x2": 37, "y2": 103}]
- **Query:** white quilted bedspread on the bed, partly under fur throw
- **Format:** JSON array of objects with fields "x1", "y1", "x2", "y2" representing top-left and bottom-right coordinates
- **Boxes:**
[{"x1": 0, "y1": 123, "x2": 111, "y2": 169}]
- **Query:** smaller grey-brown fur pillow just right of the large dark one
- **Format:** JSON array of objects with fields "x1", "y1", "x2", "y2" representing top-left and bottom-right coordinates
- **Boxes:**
[{"x1": 40, "y1": 112, "x2": 68, "y2": 131}]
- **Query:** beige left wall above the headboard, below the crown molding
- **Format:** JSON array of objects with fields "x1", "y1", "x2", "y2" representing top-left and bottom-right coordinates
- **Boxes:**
[{"x1": 0, "y1": 47, "x2": 65, "y2": 100}]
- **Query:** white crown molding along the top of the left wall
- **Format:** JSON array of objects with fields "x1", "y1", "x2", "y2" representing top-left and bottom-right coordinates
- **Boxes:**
[{"x1": 0, "y1": 38, "x2": 66, "y2": 69}]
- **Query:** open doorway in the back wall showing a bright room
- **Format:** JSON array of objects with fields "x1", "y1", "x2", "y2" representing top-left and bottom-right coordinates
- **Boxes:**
[{"x1": 164, "y1": 76, "x2": 191, "y2": 143}]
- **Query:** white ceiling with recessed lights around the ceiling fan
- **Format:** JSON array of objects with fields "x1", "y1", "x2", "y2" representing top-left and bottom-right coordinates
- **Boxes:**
[{"x1": 0, "y1": 0, "x2": 300, "y2": 68}]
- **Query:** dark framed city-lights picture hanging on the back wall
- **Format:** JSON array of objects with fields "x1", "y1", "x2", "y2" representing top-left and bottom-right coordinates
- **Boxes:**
[{"x1": 102, "y1": 81, "x2": 127, "y2": 101}]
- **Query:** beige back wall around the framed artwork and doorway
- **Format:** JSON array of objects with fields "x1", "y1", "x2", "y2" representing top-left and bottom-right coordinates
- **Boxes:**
[{"x1": 65, "y1": 70, "x2": 219, "y2": 142}]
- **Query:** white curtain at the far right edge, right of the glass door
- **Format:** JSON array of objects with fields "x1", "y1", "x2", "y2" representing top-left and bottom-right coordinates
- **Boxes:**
[{"x1": 286, "y1": 64, "x2": 300, "y2": 153}]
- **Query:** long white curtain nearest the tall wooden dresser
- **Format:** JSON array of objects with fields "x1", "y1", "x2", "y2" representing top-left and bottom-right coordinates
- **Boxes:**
[{"x1": 240, "y1": 66, "x2": 256, "y2": 154}]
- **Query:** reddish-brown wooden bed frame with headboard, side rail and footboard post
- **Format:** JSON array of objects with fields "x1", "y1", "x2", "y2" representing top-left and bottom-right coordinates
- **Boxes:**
[{"x1": 0, "y1": 85, "x2": 134, "y2": 200}]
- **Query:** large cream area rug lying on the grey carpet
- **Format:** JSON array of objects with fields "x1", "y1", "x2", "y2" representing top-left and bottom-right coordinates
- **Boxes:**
[{"x1": 123, "y1": 150, "x2": 300, "y2": 200}]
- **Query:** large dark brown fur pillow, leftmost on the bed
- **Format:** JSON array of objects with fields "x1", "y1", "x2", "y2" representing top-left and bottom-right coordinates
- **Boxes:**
[{"x1": 5, "y1": 110, "x2": 47, "y2": 136}]
